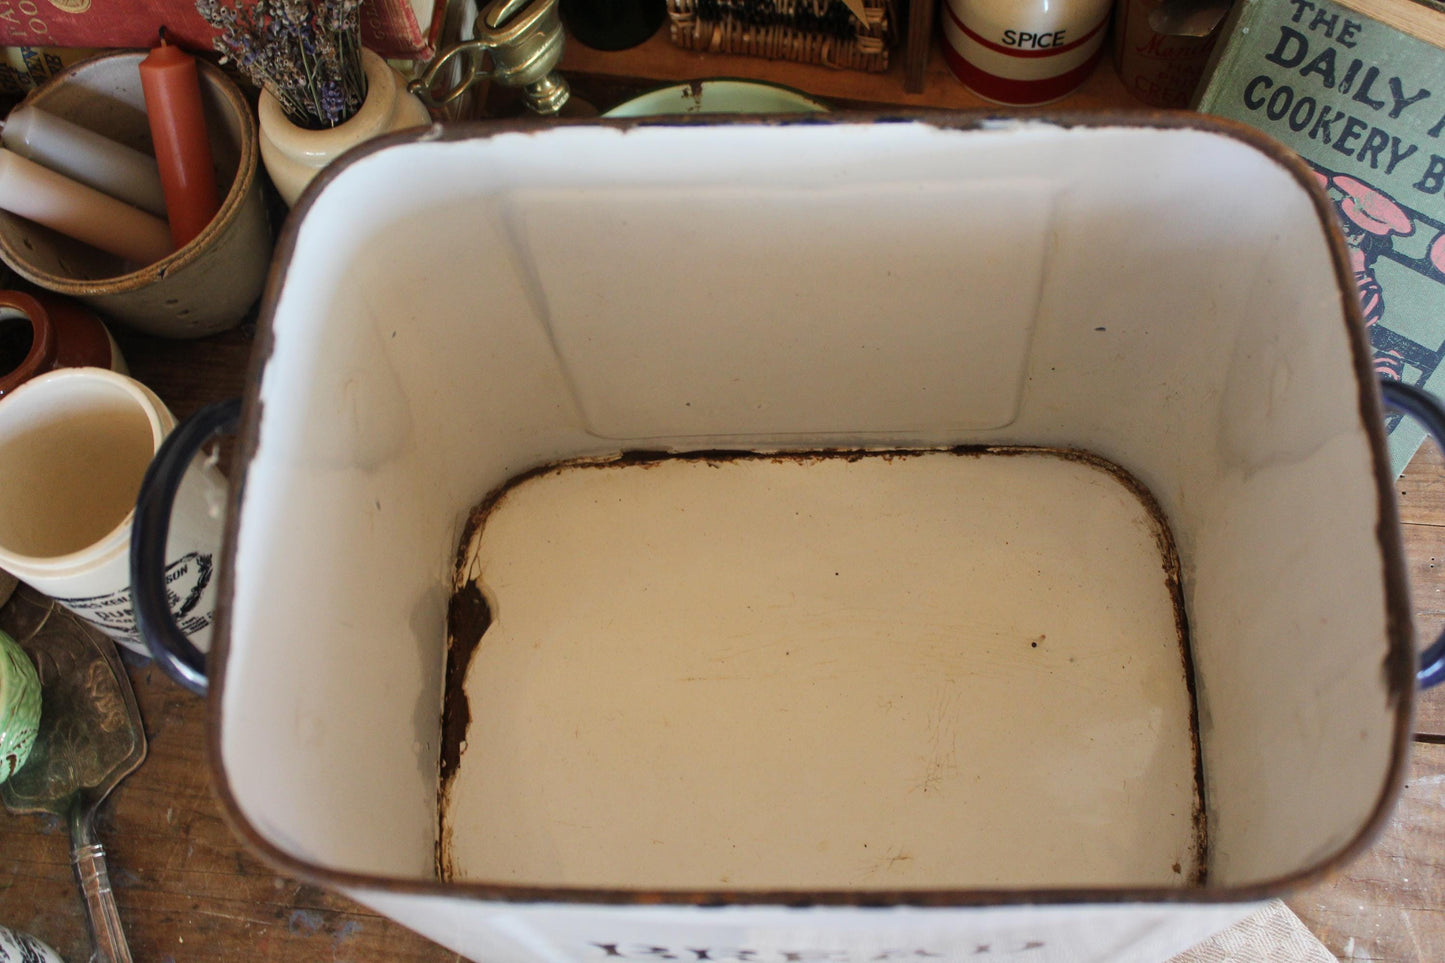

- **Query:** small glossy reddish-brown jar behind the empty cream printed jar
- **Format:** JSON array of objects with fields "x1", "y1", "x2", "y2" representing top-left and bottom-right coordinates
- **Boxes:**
[{"x1": 0, "y1": 291, "x2": 126, "y2": 396}]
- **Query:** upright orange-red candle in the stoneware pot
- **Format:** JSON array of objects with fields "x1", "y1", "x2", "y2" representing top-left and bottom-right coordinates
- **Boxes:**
[{"x1": 140, "y1": 38, "x2": 221, "y2": 247}]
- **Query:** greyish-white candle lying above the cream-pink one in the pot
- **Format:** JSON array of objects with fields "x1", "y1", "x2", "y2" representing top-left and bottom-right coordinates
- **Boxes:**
[{"x1": 0, "y1": 106, "x2": 166, "y2": 217}]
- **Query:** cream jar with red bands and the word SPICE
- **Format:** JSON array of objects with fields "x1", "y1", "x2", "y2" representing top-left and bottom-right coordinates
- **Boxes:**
[{"x1": 942, "y1": 0, "x2": 1111, "y2": 104}]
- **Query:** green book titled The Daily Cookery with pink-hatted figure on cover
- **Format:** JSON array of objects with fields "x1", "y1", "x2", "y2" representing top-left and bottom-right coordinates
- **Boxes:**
[{"x1": 1195, "y1": 0, "x2": 1445, "y2": 473}]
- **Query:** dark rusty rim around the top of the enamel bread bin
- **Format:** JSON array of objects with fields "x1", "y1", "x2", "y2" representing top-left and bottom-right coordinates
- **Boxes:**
[{"x1": 207, "y1": 110, "x2": 1416, "y2": 908}]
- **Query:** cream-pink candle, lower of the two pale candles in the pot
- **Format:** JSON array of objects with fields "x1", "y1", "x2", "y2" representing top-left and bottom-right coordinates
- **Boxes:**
[{"x1": 0, "y1": 149, "x2": 173, "y2": 265}]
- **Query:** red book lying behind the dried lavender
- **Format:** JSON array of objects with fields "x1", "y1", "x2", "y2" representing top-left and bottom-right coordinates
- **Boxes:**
[{"x1": 0, "y1": 0, "x2": 447, "y2": 61}]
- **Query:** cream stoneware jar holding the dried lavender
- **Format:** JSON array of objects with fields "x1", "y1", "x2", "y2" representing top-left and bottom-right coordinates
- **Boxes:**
[{"x1": 257, "y1": 49, "x2": 432, "y2": 207}]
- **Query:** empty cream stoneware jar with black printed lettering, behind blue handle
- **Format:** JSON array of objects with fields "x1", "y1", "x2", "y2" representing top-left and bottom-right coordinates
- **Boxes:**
[{"x1": 0, "y1": 367, "x2": 225, "y2": 655}]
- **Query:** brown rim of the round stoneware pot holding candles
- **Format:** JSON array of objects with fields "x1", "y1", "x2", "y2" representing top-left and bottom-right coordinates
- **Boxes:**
[{"x1": 0, "y1": 51, "x2": 260, "y2": 298}]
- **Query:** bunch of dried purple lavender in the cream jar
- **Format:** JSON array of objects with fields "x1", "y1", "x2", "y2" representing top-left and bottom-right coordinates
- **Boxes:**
[{"x1": 195, "y1": 0, "x2": 366, "y2": 130}]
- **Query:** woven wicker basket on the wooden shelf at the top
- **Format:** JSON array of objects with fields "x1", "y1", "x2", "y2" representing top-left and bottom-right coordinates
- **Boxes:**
[{"x1": 668, "y1": 0, "x2": 896, "y2": 72}]
